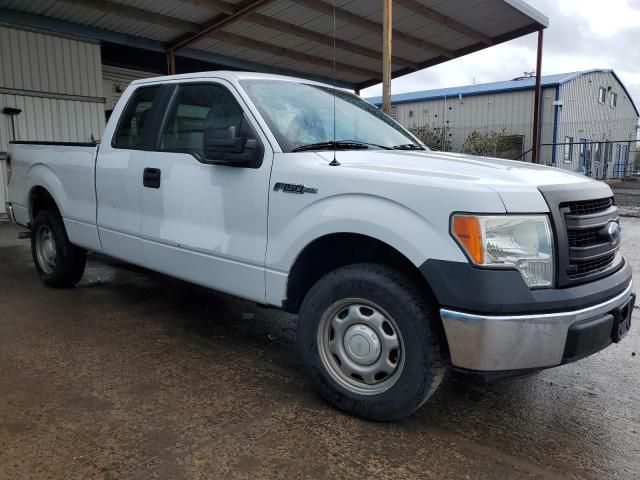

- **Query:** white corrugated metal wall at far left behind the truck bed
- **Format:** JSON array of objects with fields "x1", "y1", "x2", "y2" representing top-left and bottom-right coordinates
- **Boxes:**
[{"x1": 0, "y1": 25, "x2": 104, "y2": 151}]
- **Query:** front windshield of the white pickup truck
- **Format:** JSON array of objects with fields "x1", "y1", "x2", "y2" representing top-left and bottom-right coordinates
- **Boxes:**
[{"x1": 240, "y1": 80, "x2": 424, "y2": 152}]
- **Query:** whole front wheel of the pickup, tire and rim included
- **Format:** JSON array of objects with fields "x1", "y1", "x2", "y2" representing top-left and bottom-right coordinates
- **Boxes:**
[{"x1": 298, "y1": 264, "x2": 448, "y2": 421}]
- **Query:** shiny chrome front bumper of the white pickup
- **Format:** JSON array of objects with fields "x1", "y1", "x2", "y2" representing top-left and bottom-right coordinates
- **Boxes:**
[{"x1": 440, "y1": 283, "x2": 633, "y2": 372}]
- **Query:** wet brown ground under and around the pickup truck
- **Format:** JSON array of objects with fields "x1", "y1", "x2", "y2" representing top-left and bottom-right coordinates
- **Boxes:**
[{"x1": 0, "y1": 218, "x2": 640, "y2": 480}]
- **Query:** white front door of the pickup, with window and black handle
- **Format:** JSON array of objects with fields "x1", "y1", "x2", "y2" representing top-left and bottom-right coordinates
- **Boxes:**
[{"x1": 142, "y1": 81, "x2": 273, "y2": 301}]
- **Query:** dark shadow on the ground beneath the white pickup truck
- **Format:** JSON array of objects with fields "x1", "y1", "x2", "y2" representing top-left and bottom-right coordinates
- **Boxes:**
[{"x1": 78, "y1": 254, "x2": 535, "y2": 403}]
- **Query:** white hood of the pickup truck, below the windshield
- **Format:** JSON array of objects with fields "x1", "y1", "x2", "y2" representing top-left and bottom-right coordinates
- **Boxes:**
[{"x1": 318, "y1": 150, "x2": 613, "y2": 212}]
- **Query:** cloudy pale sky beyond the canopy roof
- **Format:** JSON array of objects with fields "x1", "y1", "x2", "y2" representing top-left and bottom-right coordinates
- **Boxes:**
[{"x1": 361, "y1": 0, "x2": 640, "y2": 107}]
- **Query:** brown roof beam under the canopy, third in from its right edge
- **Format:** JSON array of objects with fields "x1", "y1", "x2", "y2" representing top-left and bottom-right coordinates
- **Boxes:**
[{"x1": 182, "y1": 0, "x2": 418, "y2": 70}]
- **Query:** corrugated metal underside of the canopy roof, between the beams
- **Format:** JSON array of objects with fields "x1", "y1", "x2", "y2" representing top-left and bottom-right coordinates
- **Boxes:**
[{"x1": 0, "y1": 0, "x2": 548, "y2": 87}]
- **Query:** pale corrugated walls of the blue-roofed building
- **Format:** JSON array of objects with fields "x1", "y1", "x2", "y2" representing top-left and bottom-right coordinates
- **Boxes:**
[{"x1": 394, "y1": 72, "x2": 638, "y2": 172}]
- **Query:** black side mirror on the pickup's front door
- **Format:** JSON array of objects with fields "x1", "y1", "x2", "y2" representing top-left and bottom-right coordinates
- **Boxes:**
[{"x1": 203, "y1": 117, "x2": 264, "y2": 168}]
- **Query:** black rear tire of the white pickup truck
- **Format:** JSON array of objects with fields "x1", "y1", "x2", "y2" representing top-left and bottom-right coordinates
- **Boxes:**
[{"x1": 31, "y1": 210, "x2": 87, "y2": 288}]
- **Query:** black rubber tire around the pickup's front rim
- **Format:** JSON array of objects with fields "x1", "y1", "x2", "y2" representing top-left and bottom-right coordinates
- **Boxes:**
[{"x1": 297, "y1": 263, "x2": 450, "y2": 421}]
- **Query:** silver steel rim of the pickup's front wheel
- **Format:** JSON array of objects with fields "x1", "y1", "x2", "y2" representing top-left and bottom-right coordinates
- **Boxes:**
[{"x1": 317, "y1": 298, "x2": 405, "y2": 395}]
